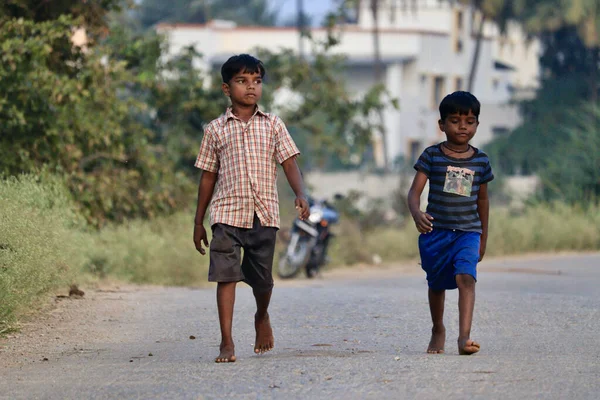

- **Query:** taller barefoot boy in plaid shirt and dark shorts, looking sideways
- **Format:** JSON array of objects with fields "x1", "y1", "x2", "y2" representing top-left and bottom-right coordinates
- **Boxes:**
[{"x1": 194, "y1": 54, "x2": 309, "y2": 363}]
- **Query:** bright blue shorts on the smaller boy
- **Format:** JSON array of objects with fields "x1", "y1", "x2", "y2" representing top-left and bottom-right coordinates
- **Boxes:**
[{"x1": 419, "y1": 229, "x2": 481, "y2": 290}]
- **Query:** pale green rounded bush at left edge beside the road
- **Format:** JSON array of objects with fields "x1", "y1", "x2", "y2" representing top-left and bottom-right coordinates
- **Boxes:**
[{"x1": 0, "y1": 174, "x2": 87, "y2": 332}]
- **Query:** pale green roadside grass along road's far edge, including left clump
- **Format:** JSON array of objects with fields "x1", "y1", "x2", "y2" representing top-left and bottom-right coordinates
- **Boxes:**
[{"x1": 0, "y1": 174, "x2": 600, "y2": 333}]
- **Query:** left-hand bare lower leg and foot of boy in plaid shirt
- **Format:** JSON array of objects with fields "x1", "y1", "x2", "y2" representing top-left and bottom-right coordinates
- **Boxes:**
[{"x1": 215, "y1": 282, "x2": 237, "y2": 363}]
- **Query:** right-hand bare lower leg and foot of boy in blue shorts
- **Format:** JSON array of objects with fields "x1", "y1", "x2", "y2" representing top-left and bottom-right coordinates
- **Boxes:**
[{"x1": 456, "y1": 274, "x2": 480, "y2": 355}]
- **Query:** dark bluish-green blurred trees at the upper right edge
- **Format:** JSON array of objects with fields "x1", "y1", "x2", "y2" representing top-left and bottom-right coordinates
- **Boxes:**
[{"x1": 487, "y1": 0, "x2": 600, "y2": 202}]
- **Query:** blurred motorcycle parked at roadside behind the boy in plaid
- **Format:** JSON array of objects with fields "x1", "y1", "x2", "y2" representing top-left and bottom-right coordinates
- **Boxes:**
[{"x1": 277, "y1": 198, "x2": 339, "y2": 279}]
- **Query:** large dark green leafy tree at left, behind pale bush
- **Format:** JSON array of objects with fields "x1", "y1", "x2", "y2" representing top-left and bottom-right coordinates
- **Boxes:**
[{"x1": 0, "y1": 16, "x2": 191, "y2": 228}]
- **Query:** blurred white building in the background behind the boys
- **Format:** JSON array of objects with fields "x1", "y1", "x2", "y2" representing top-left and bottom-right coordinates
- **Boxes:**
[{"x1": 157, "y1": 0, "x2": 539, "y2": 169}]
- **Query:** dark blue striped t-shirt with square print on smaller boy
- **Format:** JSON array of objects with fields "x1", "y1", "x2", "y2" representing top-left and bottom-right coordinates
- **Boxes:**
[{"x1": 414, "y1": 144, "x2": 494, "y2": 233}]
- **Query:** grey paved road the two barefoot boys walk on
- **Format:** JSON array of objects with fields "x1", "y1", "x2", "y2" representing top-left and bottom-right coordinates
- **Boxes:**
[{"x1": 0, "y1": 254, "x2": 600, "y2": 400}]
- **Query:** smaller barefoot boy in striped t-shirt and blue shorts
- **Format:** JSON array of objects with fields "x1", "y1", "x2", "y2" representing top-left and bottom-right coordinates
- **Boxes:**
[{"x1": 408, "y1": 91, "x2": 494, "y2": 355}]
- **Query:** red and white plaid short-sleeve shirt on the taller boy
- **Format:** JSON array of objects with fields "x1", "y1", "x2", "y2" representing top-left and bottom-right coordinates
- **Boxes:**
[{"x1": 195, "y1": 108, "x2": 300, "y2": 228}]
